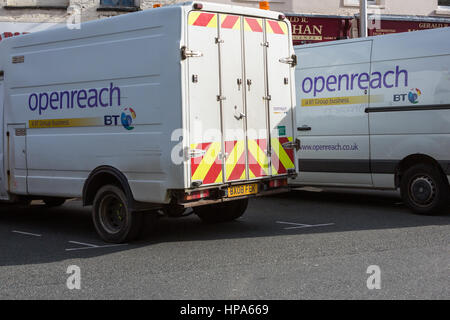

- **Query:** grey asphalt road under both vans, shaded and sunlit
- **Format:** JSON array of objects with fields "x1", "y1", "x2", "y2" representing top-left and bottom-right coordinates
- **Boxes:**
[{"x1": 0, "y1": 190, "x2": 450, "y2": 299}]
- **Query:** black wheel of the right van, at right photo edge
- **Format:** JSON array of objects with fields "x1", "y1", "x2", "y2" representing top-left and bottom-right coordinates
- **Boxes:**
[{"x1": 400, "y1": 164, "x2": 450, "y2": 215}]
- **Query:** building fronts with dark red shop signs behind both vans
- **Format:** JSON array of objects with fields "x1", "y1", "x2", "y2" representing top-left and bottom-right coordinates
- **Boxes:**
[{"x1": 0, "y1": 0, "x2": 450, "y2": 44}]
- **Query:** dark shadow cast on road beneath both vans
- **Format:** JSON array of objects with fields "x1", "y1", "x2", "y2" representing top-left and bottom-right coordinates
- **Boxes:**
[{"x1": 0, "y1": 189, "x2": 450, "y2": 266}]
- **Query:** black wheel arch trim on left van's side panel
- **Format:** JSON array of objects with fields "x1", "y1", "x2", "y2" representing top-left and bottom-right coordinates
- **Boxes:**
[{"x1": 83, "y1": 166, "x2": 135, "y2": 209}]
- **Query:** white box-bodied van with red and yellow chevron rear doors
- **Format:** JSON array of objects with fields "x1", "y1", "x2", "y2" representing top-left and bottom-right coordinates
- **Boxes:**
[{"x1": 0, "y1": 2, "x2": 296, "y2": 242}]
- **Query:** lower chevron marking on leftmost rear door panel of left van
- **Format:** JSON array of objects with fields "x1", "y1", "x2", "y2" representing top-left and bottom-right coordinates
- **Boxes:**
[{"x1": 191, "y1": 142, "x2": 222, "y2": 184}]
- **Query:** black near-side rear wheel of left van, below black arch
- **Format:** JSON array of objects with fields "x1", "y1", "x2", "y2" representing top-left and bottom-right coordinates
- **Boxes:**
[{"x1": 92, "y1": 185, "x2": 143, "y2": 243}]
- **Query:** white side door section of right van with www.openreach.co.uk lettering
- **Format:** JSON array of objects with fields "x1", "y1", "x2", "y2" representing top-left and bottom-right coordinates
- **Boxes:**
[{"x1": 292, "y1": 41, "x2": 372, "y2": 187}]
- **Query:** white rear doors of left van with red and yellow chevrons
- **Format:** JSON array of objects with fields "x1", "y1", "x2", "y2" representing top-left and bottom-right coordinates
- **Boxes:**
[{"x1": 187, "y1": 11, "x2": 295, "y2": 185}]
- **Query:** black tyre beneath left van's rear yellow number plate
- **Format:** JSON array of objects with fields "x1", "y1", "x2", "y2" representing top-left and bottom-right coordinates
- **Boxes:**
[{"x1": 194, "y1": 199, "x2": 248, "y2": 223}]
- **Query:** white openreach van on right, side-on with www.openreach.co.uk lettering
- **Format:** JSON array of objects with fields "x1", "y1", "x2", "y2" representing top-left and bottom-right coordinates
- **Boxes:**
[{"x1": 291, "y1": 28, "x2": 450, "y2": 214}]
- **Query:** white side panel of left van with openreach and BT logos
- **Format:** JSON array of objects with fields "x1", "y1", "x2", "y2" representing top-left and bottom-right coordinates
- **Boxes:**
[{"x1": 5, "y1": 7, "x2": 184, "y2": 203}]
